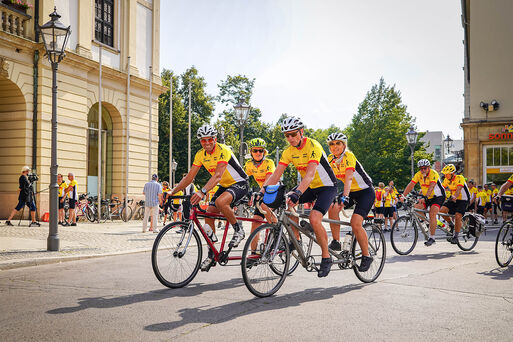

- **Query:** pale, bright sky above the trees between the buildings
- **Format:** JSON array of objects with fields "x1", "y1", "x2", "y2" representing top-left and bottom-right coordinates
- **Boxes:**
[{"x1": 160, "y1": 0, "x2": 463, "y2": 138}]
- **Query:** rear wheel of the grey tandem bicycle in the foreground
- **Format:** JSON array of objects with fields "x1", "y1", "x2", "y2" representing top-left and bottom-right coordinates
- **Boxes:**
[{"x1": 351, "y1": 223, "x2": 386, "y2": 283}]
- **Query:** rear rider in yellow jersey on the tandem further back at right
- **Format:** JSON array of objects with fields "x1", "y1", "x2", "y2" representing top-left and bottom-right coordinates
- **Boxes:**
[{"x1": 440, "y1": 164, "x2": 470, "y2": 245}]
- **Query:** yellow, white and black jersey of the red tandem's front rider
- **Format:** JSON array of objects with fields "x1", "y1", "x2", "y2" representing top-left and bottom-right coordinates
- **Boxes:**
[{"x1": 192, "y1": 143, "x2": 248, "y2": 188}]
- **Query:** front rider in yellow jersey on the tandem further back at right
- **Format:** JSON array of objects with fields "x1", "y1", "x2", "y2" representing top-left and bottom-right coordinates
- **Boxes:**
[{"x1": 401, "y1": 159, "x2": 445, "y2": 247}]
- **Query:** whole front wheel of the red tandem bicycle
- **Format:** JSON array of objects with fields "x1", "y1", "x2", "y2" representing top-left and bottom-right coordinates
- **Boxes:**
[{"x1": 151, "y1": 221, "x2": 202, "y2": 288}]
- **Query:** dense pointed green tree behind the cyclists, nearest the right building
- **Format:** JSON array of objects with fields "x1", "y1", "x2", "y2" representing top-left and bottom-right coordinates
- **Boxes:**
[{"x1": 345, "y1": 78, "x2": 432, "y2": 187}]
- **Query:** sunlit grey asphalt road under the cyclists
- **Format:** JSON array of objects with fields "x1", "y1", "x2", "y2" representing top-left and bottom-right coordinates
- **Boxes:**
[{"x1": 0, "y1": 232, "x2": 513, "y2": 341}]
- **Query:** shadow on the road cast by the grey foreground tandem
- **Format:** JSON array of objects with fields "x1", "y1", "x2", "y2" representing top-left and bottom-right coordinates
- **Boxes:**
[{"x1": 144, "y1": 284, "x2": 371, "y2": 332}]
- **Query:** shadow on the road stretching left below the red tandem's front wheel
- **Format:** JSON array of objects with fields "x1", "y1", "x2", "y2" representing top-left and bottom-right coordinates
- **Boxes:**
[{"x1": 46, "y1": 278, "x2": 244, "y2": 314}]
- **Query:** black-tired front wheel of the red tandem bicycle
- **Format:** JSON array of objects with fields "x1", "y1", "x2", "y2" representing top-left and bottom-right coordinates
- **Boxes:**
[{"x1": 151, "y1": 221, "x2": 203, "y2": 289}]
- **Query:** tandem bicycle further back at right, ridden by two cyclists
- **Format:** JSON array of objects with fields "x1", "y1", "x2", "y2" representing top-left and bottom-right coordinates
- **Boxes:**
[{"x1": 390, "y1": 191, "x2": 486, "y2": 255}]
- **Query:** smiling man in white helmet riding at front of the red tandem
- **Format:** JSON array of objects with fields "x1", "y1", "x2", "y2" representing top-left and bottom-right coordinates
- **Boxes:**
[{"x1": 171, "y1": 124, "x2": 249, "y2": 271}]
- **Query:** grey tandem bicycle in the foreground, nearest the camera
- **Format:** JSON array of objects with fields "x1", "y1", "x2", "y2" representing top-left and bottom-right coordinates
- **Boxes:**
[{"x1": 241, "y1": 201, "x2": 386, "y2": 297}]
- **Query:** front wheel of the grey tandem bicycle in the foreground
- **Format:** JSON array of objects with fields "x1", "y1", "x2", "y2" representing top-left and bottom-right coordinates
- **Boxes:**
[{"x1": 241, "y1": 224, "x2": 290, "y2": 297}]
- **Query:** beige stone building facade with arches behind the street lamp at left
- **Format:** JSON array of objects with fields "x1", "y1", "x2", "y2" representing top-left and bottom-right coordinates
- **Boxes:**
[{"x1": 0, "y1": 0, "x2": 165, "y2": 218}]
